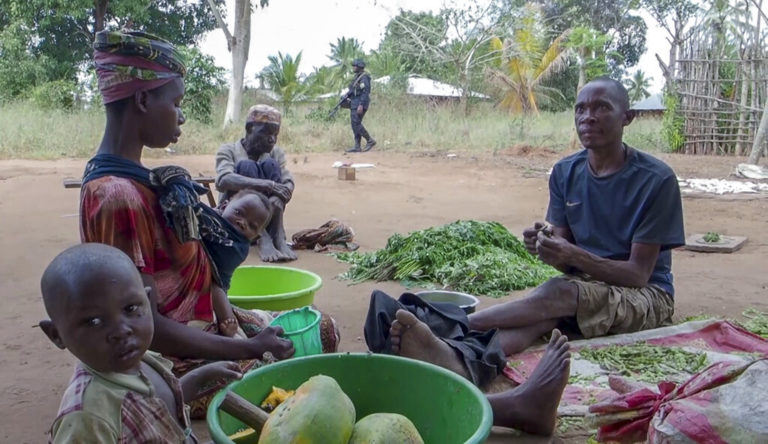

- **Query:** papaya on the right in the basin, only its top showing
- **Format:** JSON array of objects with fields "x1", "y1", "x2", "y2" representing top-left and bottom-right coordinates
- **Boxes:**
[{"x1": 349, "y1": 413, "x2": 424, "y2": 444}]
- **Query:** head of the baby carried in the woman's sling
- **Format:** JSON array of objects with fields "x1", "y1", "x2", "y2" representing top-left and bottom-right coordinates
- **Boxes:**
[{"x1": 221, "y1": 189, "x2": 272, "y2": 241}]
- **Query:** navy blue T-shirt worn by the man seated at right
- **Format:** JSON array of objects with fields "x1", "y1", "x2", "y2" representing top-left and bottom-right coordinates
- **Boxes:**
[{"x1": 547, "y1": 147, "x2": 685, "y2": 296}]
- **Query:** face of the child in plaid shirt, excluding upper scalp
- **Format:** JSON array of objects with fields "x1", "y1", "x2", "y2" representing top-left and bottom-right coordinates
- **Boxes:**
[{"x1": 41, "y1": 267, "x2": 154, "y2": 373}]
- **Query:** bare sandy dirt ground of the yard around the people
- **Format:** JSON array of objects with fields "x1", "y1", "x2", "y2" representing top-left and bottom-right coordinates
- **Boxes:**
[{"x1": 0, "y1": 149, "x2": 768, "y2": 443}]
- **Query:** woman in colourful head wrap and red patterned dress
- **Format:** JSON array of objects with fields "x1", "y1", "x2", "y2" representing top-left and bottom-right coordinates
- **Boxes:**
[{"x1": 80, "y1": 31, "x2": 338, "y2": 414}]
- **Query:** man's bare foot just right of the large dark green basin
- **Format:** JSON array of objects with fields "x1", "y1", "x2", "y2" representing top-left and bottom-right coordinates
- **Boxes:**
[{"x1": 488, "y1": 330, "x2": 571, "y2": 436}]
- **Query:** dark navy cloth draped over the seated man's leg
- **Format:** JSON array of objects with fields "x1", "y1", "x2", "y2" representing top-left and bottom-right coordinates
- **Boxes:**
[{"x1": 364, "y1": 290, "x2": 507, "y2": 387}]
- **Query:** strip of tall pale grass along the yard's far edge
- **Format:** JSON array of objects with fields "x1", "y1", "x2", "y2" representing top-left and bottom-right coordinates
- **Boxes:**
[{"x1": 0, "y1": 91, "x2": 665, "y2": 159}]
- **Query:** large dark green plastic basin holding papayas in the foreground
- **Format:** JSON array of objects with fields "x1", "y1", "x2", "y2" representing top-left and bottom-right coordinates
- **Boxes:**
[{"x1": 207, "y1": 353, "x2": 493, "y2": 444}]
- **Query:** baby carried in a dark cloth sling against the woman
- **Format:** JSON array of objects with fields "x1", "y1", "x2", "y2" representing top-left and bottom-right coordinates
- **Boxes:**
[{"x1": 203, "y1": 189, "x2": 270, "y2": 337}]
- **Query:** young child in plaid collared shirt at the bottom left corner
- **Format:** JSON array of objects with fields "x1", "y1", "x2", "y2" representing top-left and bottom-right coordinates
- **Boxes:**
[{"x1": 40, "y1": 243, "x2": 242, "y2": 443}]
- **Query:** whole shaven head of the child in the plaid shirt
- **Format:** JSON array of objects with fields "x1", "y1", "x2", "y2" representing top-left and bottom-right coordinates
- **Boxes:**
[{"x1": 40, "y1": 243, "x2": 154, "y2": 373}]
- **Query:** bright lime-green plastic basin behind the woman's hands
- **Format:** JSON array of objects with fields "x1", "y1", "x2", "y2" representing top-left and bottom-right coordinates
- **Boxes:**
[{"x1": 228, "y1": 265, "x2": 323, "y2": 311}]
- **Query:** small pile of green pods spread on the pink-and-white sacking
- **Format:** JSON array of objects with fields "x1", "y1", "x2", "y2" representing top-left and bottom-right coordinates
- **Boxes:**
[{"x1": 579, "y1": 342, "x2": 707, "y2": 384}]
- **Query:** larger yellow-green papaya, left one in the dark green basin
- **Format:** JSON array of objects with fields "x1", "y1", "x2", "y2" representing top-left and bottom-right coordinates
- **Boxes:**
[{"x1": 259, "y1": 375, "x2": 355, "y2": 444}]
